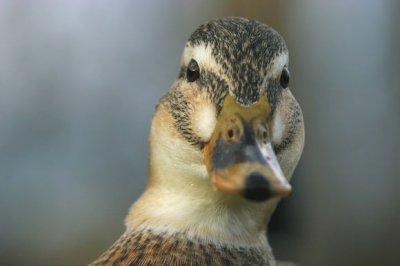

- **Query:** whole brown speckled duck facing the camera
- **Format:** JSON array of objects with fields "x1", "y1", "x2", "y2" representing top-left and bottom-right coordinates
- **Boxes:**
[{"x1": 90, "y1": 17, "x2": 305, "y2": 265}]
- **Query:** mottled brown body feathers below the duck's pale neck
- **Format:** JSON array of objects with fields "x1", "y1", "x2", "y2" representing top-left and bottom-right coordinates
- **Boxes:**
[{"x1": 90, "y1": 230, "x2": 275, "y2": 266}]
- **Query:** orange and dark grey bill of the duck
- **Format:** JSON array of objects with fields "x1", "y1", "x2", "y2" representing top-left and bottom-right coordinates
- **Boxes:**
[{"x1": 204, "y1": 95, "x2": 291, "y2": 201}]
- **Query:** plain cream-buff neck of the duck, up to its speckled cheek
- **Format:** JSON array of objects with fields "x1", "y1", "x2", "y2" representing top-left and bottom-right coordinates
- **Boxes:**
[{"x1": 126, "y1": 105, "x2": 278, "y2": 245}]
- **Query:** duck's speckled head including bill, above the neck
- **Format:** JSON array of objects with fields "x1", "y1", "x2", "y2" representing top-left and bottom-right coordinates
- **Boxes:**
[{"x1": 150, "y1": 18, "x2": 304, "y2": 204}]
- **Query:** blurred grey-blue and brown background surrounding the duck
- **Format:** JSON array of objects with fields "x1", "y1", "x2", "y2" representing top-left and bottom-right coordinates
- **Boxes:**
[{"x1": 0, "y1": 0, "x2": 400, "y2": 265}]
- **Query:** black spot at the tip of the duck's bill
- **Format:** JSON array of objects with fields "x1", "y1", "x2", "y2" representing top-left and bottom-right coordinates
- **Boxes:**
[{"x1": 244, "y1": 172, "x2": 271, "y2": 201}]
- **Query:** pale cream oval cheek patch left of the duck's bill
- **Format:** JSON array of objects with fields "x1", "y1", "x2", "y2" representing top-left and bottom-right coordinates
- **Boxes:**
[{"x1": 192, "y1": 102, "x2": 217, "y2": 142}]
